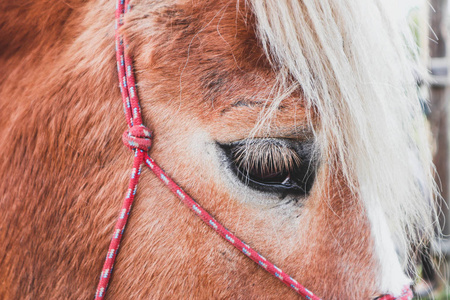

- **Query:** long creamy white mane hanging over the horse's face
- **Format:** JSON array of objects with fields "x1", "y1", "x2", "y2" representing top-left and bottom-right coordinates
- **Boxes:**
[{"x1": 250, "y1": 0, "x2": 436, "y2": 270}]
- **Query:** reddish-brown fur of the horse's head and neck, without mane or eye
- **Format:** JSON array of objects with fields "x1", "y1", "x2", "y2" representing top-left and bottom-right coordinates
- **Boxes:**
[{"x1": 0, "y1": 0, "x2": 377, "y2": 299}]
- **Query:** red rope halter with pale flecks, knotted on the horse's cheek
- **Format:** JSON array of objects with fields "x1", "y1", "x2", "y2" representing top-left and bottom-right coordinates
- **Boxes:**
[{"x1": 95, "y1": 0, "x2": 412, "y2": 300}]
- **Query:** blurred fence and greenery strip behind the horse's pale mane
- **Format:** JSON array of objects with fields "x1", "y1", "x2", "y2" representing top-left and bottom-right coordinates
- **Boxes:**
[{"x1": 400, "y1": 0, "x2": 450, "y2": 300}]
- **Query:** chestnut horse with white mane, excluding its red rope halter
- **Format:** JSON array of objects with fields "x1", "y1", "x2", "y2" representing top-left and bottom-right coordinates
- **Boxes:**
[{"x1": 0, "y1": 0, "x2": 436, "y2": 299}]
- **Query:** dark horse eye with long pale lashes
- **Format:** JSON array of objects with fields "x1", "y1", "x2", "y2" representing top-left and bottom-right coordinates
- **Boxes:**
[{"x1": 219, "y1": 139, "x2": 315, "y2": 196}]
